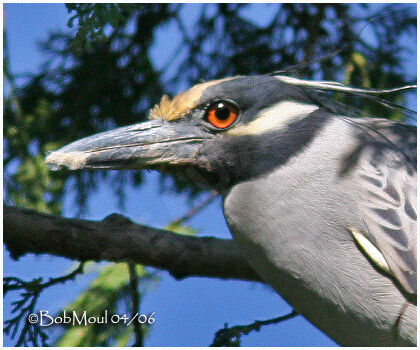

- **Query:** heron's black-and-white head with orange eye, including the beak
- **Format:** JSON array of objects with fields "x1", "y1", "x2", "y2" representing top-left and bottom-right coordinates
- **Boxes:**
[{"x1": 46, "y1": 75, "x2": 334, "y2": 190}]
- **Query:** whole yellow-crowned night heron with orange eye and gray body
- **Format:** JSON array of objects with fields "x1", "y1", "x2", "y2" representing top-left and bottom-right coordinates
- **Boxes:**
[{"x1": 47, "y1": 75, "x2": 417, "y2": 345}]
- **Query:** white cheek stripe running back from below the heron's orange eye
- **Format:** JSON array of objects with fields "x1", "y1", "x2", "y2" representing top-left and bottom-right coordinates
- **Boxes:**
[{"x1": 226, "y1": 101, "x2": 319, "y2": 135}]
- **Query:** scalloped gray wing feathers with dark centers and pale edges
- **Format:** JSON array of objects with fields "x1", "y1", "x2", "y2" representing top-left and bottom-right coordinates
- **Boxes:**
[{"x1": 360, "y1": 160, "x2": 417, "y2": 294}]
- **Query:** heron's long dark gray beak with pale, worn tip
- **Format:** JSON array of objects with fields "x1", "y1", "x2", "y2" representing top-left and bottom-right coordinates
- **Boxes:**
[{"x1": 46, "y1": 119, "x2": 211, "y2": 170}]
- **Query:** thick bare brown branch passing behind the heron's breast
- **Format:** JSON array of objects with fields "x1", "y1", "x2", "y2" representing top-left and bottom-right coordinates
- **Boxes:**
[{"x1": 3, "y1": 206, "x2": 261, "y2": 282}]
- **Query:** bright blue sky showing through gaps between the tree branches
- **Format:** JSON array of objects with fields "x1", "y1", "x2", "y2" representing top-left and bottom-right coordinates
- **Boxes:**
[{"x1": 4, "y1": 4, "x2": 416, "y2": 346}]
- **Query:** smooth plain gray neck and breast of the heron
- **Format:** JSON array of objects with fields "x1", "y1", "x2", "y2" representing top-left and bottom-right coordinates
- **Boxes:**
[{"x1": 224, "y1": 118, "x2": 416, "y2": 345}]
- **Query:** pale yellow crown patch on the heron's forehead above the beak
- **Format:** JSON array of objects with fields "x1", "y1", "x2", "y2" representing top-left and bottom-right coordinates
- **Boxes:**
[{"x1": 149, "y1": 77, "x2": 236, "y2": 121}]
